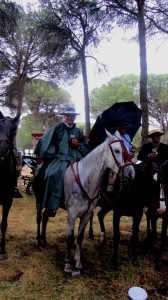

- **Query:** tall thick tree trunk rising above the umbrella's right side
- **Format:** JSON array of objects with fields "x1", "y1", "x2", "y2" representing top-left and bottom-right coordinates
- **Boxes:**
[{"x1": 136, "y1": 0, "x2": 149, "y2": 144}]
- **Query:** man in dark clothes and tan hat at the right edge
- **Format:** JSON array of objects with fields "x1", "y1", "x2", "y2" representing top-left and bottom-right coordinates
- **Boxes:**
[{"x1": 137, "y1": 129, "x2": 168, "y2": 166}]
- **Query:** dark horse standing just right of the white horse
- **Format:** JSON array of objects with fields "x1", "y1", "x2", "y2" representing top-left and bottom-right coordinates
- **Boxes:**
[{"x1": 89, "y1": 165, "x2": 162, "y2": 267}]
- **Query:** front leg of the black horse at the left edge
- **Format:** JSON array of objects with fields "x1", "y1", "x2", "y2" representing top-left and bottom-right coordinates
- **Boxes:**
[{"x1": 0, "y1": 199, "x2": 12, "y2": 259}]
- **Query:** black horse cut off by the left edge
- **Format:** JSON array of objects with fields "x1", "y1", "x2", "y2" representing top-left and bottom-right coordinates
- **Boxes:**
[{"x1": 0, "y1": 112, "x2": 19, "y2": 259}]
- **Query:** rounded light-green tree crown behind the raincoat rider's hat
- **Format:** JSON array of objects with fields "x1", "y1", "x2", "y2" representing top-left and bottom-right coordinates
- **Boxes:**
[{"x1": 25, "y1": 79, "x2": 72, "y2": 132}]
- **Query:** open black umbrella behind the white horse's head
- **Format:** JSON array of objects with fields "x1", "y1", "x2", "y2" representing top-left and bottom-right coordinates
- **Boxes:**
[{"x1": 89, "y1": 101, "x2": 142, "y2": 149}]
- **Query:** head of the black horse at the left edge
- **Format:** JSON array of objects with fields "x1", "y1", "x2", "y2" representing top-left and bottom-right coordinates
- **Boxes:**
[{"x1": 0, "y1": 112, "x2": 20, "y2": 161}]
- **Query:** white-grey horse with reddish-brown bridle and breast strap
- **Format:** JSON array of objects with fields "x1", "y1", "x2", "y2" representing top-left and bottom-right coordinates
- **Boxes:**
[{"x1": 64, "y1": 132, "x2": 135, "y2": 274}]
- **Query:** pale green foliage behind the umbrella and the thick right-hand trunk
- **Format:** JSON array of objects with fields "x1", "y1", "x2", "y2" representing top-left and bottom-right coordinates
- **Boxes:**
[{"x1": 90, "y1": 74, "x2": 168, "y2": 140}]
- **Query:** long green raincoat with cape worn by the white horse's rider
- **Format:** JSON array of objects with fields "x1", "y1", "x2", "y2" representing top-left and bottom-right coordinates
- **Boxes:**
[{"x1": 34, "y1": 123, "x2": 90, "y2": 210}]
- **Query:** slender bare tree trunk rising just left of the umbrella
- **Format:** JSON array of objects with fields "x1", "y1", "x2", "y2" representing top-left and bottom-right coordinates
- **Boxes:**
[{"x1": 79, "y1": 53, "x2": 90, "y2": 134}]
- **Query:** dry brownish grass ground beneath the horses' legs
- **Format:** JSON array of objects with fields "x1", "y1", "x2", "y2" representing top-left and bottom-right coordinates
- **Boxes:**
[{"x1": 0, "y1": 178, "x2": 168, "y2": 300}]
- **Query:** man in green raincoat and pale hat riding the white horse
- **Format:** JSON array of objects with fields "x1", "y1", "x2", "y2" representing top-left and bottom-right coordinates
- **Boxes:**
[{"x1": 33, "y1": 107, "x2": 90, "y2": 216}]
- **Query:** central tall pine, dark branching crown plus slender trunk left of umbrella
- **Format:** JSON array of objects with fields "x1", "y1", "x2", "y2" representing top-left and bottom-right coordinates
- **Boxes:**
[{"x1": 36, "y1": 0, "x2": 109, "y2": 132}]
